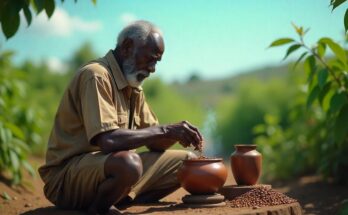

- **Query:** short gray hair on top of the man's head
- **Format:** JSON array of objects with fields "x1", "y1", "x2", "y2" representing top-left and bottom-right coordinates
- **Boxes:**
[{"x1": 117, "y1": 20, "x2": 162, "y2": 46}]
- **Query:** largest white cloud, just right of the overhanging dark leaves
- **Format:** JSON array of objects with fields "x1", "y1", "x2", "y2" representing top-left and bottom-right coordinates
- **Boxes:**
[{"x1": 22, "y1": 8, "x2": 102, "y2": 37}]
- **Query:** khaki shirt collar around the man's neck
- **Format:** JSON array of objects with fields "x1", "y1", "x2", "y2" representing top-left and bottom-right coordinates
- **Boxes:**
[{"x1": 104, "y1": 50, "x2": 143, "y2": 91}]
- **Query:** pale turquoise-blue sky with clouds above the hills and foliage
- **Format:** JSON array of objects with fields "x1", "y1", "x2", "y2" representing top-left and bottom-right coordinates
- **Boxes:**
[{"x1": 0, "y1": 0, "x2": 347, "y2": 82}]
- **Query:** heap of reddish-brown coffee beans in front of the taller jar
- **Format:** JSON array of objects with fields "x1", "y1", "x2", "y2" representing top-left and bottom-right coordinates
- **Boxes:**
[{"x1": 227, "y1": 187, "x2": 297, "y2": 208}]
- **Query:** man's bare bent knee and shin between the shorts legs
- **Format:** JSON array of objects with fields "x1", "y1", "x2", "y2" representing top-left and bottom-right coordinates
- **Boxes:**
[{"x1": 88, "y1": 151, "x2": 142, "y2": 214}]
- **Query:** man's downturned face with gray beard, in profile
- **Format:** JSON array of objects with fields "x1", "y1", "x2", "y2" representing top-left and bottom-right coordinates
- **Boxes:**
[{"x1": 122, "y1": 33, "x2": 164, "y2": 87}]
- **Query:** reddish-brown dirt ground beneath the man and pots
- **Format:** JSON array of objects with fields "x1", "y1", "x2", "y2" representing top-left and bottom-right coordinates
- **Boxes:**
[{"x1": 0, "y1": 159, "x2": 348, "y2": 215}]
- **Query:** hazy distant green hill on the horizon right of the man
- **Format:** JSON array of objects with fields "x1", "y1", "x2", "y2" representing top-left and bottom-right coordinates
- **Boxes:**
[{"x1": 171, "y1": 65, "x2": 289, "y2": 107}]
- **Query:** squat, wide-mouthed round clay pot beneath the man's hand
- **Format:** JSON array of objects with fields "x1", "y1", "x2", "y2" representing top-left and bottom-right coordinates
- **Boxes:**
[{"x1": 178, "y1": 158, "x2": 227, "y2": 195}]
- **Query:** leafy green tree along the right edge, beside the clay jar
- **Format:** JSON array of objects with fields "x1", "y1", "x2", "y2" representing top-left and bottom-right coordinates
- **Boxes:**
[{"x1": 261, "y1": 0, "x2": 348, "y2": 183}]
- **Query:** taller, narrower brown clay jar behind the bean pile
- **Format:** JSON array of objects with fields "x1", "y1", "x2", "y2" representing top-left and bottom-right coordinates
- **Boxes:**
[{"x1": 231, "y1": 145, "x2": 262, "y2": 185}]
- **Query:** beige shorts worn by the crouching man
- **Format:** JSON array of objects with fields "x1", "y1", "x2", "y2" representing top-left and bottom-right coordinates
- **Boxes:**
[{"x1": 52, "y1": 150, "x2": 189, "y2": 209}]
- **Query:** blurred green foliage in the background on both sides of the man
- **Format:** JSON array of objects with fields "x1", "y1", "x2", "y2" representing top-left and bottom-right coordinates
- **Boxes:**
[{"x1": 0, "y1": 1, "x2": 348, "y2": 186}]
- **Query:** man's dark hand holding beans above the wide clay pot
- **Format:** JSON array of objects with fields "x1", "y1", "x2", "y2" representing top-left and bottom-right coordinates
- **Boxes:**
[{"x1": 162, "y1": 121, "x2": 203, "y2": 150}]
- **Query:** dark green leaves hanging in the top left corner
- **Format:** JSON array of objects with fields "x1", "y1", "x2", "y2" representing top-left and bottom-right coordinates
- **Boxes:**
[{"x1": 0, "y1": 0, "x2": 97, "y2": 39}]
